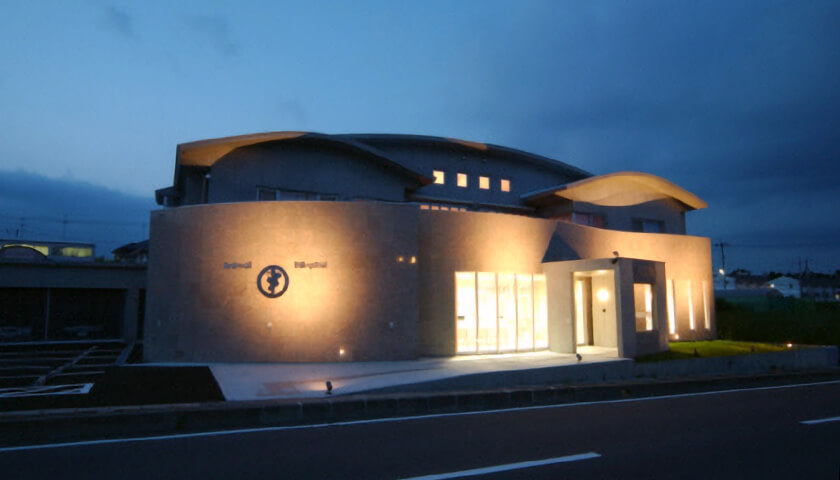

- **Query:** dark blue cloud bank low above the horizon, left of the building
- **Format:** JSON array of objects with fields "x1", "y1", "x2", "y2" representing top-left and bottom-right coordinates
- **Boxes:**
[{"x1": 0, "y1": 170, "x2": 156, "y2": 256}]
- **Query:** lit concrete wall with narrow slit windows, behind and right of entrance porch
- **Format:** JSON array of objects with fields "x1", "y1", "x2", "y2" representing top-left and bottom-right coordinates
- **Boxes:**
[{"x1": 546, "y1": 222, "x2": 715, "y2": 340}]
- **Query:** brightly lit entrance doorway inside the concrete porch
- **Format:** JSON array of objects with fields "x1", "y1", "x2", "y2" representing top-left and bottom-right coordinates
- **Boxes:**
[{"x1": 573, "y1": 270, "x2": 618, "y2": 348}]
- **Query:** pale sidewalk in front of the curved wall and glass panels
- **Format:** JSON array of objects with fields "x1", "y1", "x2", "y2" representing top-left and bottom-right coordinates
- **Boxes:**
[{"x1": 204, "y1": 347, "x2": 632, "y2": 401}]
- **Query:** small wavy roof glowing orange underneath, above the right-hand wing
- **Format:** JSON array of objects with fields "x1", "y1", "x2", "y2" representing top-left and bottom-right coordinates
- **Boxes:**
[{"x1": 520, "y1": 172, "x2": 708, "y2": 210}]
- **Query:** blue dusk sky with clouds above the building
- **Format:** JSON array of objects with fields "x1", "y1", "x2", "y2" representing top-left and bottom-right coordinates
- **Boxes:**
[{"x1": 0, "y1": 0, "x2": 840, "y2": 272}]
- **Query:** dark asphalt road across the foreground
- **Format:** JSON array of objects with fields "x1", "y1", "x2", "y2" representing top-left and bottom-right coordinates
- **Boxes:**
[{"x1": 0, "y1": 381, "x2": 840, "y2": 479}]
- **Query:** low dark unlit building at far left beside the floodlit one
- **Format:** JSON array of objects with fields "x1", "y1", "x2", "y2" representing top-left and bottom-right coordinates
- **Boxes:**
[{"x1": 0, "y1": 240, "x2": 146, "y2": 343}]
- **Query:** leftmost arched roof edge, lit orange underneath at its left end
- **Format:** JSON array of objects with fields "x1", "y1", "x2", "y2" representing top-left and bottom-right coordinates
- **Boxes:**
[{"x1": 175, "y1": 132, "x2": 434, "y2": 185}]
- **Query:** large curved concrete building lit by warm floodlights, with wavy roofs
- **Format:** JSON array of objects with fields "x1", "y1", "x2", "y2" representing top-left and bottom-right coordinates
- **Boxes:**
[{"x1": 144, "y1": 132, "x2": 715, "y2": 361}]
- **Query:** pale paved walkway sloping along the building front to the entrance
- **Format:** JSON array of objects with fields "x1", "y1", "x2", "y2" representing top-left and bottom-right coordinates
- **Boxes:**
[{"x1": 204, "y1": 347, "x2": 623, "y2": 401}]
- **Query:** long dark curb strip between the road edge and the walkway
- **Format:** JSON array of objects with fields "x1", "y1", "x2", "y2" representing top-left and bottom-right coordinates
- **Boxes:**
[{"x1": 0, "y1": 368, "x2": 840, "y2": 446}]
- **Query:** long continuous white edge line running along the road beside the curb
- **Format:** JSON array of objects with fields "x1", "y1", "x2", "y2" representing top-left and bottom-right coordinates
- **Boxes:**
[{"x1": 0, "y1": 380, "x2": 840, "y2": 453}]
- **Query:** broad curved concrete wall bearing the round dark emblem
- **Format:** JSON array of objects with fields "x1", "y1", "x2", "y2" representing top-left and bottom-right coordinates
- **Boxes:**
[{"x1": 144, "y1": 202, "x2": 419, "y2": 362}]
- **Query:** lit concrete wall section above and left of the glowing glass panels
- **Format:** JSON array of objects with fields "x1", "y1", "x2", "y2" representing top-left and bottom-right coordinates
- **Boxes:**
[{"x1": 415, "y1": 207, "x2": 556, "y2": 355}]
